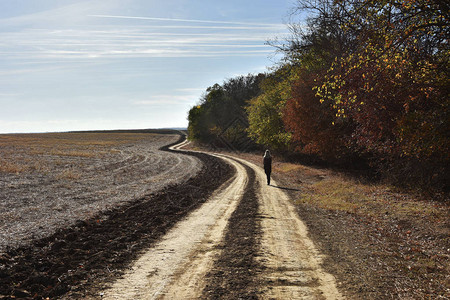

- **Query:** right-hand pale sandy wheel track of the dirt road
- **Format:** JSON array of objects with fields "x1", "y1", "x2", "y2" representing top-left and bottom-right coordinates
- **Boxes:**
[{"x1": 234, "y1": 160, "x2": 343, "y2": 299}]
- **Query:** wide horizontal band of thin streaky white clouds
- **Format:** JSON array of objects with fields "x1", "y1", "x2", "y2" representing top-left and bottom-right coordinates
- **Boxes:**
[{"x1": 0, "y1": 27, "x2": 280, "y2": 62}]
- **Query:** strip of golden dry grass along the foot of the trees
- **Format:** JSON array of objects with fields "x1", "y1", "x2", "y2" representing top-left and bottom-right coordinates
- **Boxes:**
[{"x1": 275, "y1": 162, "x2": 448, "y2": 221}]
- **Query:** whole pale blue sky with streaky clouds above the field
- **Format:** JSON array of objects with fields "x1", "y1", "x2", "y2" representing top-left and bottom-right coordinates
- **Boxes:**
[{"x1": 0, "y1": 0, "x2": 294, "y2": 133}]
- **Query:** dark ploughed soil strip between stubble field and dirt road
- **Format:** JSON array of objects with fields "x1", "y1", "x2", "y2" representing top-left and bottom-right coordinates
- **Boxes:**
[{"x1": 0, "y1": 137, "x2": 233, "y2": 299}]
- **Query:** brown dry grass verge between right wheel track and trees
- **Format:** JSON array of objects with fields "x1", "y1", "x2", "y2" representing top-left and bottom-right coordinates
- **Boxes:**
[{"x1": 268, "y1": 157, "x2": 450, "y2": 299}]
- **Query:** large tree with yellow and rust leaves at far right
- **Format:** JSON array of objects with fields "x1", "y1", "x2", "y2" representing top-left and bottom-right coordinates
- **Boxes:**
[{"x1": 317, "y1": 0, "x2": 450, "y2": 187}]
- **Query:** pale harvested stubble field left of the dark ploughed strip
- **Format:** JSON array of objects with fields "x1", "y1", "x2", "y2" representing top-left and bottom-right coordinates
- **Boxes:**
[{"x1": 0, "y1": 132, "x2": 201, "y2": 253}]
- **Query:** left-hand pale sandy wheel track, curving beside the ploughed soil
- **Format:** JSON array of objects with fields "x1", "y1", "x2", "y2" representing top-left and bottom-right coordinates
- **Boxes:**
[{"x1": 103, "y1": 158, "x2": 246, "y2": 299}]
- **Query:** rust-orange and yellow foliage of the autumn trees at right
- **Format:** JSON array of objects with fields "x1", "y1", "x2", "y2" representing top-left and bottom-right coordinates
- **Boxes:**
[{"x1": 272, "y1": 0, "x2": 450, "y2": 189}]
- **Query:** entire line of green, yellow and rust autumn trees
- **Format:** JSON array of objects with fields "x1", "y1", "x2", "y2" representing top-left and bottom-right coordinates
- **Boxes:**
[{"x1": 188, "y1": 0, "x2": 450, "y2": 191}]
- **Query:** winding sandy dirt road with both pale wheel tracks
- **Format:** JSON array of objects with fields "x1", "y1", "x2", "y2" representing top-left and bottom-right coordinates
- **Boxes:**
[{"x1": 101, "y1": 141, "x2": 342, "y2": 299}]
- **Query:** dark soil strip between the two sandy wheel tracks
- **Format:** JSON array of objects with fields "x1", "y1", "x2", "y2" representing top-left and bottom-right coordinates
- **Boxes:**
[{"x1": 202, "y1": 161, "x2": 262, "y2": 299}]
